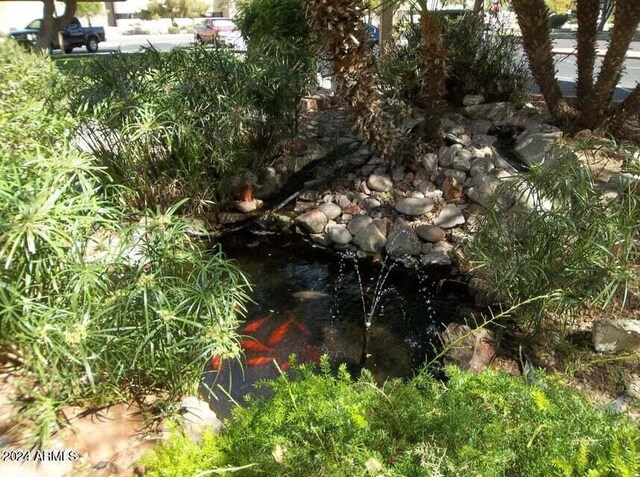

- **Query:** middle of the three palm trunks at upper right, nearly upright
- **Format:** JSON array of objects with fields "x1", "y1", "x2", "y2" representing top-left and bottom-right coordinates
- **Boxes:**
[{"x1": 576, "y1": 0, "x2": 600, "y2": 109}]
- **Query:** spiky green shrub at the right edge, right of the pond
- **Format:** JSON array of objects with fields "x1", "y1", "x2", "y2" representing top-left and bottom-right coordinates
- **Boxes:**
[{"x1": 468, "y1": 153, "x2": 640, "y2": 326}]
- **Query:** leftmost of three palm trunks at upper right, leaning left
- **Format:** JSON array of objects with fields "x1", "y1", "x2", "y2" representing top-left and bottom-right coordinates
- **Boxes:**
[{"x1": 512, "y1": 0, "x2": 573, "y2": 122}]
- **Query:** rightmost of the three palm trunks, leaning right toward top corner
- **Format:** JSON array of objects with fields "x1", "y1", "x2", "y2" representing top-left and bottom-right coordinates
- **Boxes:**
[{"x1": 583, "y1": 0, "x2": 640, "y2": 128}]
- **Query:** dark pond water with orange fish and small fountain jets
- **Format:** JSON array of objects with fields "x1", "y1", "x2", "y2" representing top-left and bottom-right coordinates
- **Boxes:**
[{"x1": 204, "y1": 233, "x2": 471, "y2": 417}]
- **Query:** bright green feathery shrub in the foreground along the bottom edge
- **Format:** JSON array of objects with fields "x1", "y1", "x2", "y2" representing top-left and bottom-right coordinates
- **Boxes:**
[{"x1": 145, "y1": 361, "x2": 640, "y2": 477}]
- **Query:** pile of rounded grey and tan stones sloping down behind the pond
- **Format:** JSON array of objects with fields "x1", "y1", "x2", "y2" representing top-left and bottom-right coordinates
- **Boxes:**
[{"x1": 280, "y1": 93, "x2": 562, "y2": 265}]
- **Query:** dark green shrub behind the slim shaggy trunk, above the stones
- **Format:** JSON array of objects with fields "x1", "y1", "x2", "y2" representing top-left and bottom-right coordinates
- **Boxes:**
[{"x1": 380, "y1": 13, "x2": 528, "y2": 106}]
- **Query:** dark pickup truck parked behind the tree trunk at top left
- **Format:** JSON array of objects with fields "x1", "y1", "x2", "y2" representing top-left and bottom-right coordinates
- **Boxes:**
[{"x1": 9, "y1": 18, "x2": 105, "y2": 53}]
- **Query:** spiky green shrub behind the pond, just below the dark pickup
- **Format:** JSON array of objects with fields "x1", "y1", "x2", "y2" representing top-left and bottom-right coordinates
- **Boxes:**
[{"x1": 67, "y1": 47, "x2": 312, "y2": 211}]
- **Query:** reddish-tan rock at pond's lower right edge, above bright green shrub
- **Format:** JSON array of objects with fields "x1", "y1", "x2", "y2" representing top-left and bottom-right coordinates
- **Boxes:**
[{"x1": 440, "y1": 323, "x2": 496, "y2": 373}]
